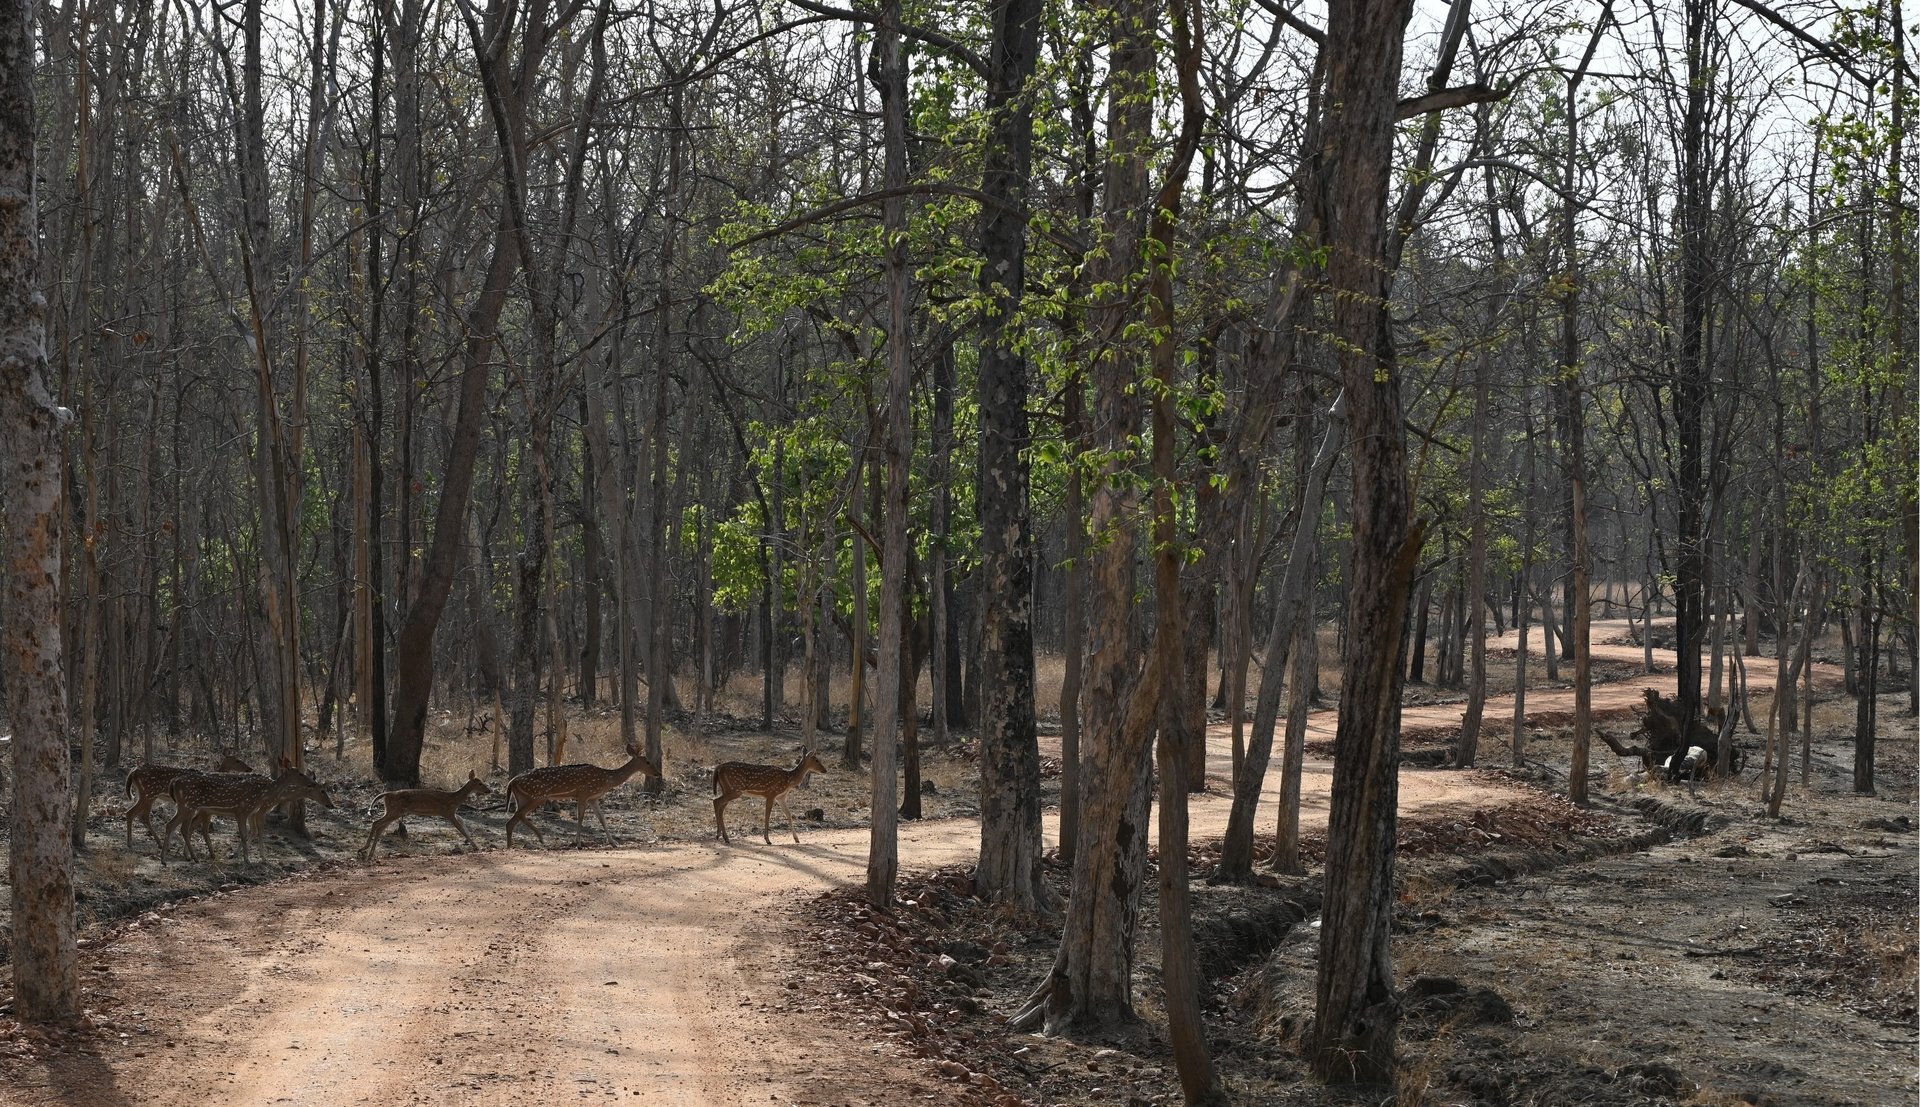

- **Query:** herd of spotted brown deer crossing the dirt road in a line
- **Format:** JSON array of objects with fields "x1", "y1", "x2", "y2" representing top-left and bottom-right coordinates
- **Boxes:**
[{"x1": 127, "y1": 750, "x2": 828, "y2": 863}]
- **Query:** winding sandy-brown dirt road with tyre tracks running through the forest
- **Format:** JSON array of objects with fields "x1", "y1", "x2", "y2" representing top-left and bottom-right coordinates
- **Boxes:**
[{"x1": 15, "y1": 624, "x2": 1837, "y2": 1107}]
